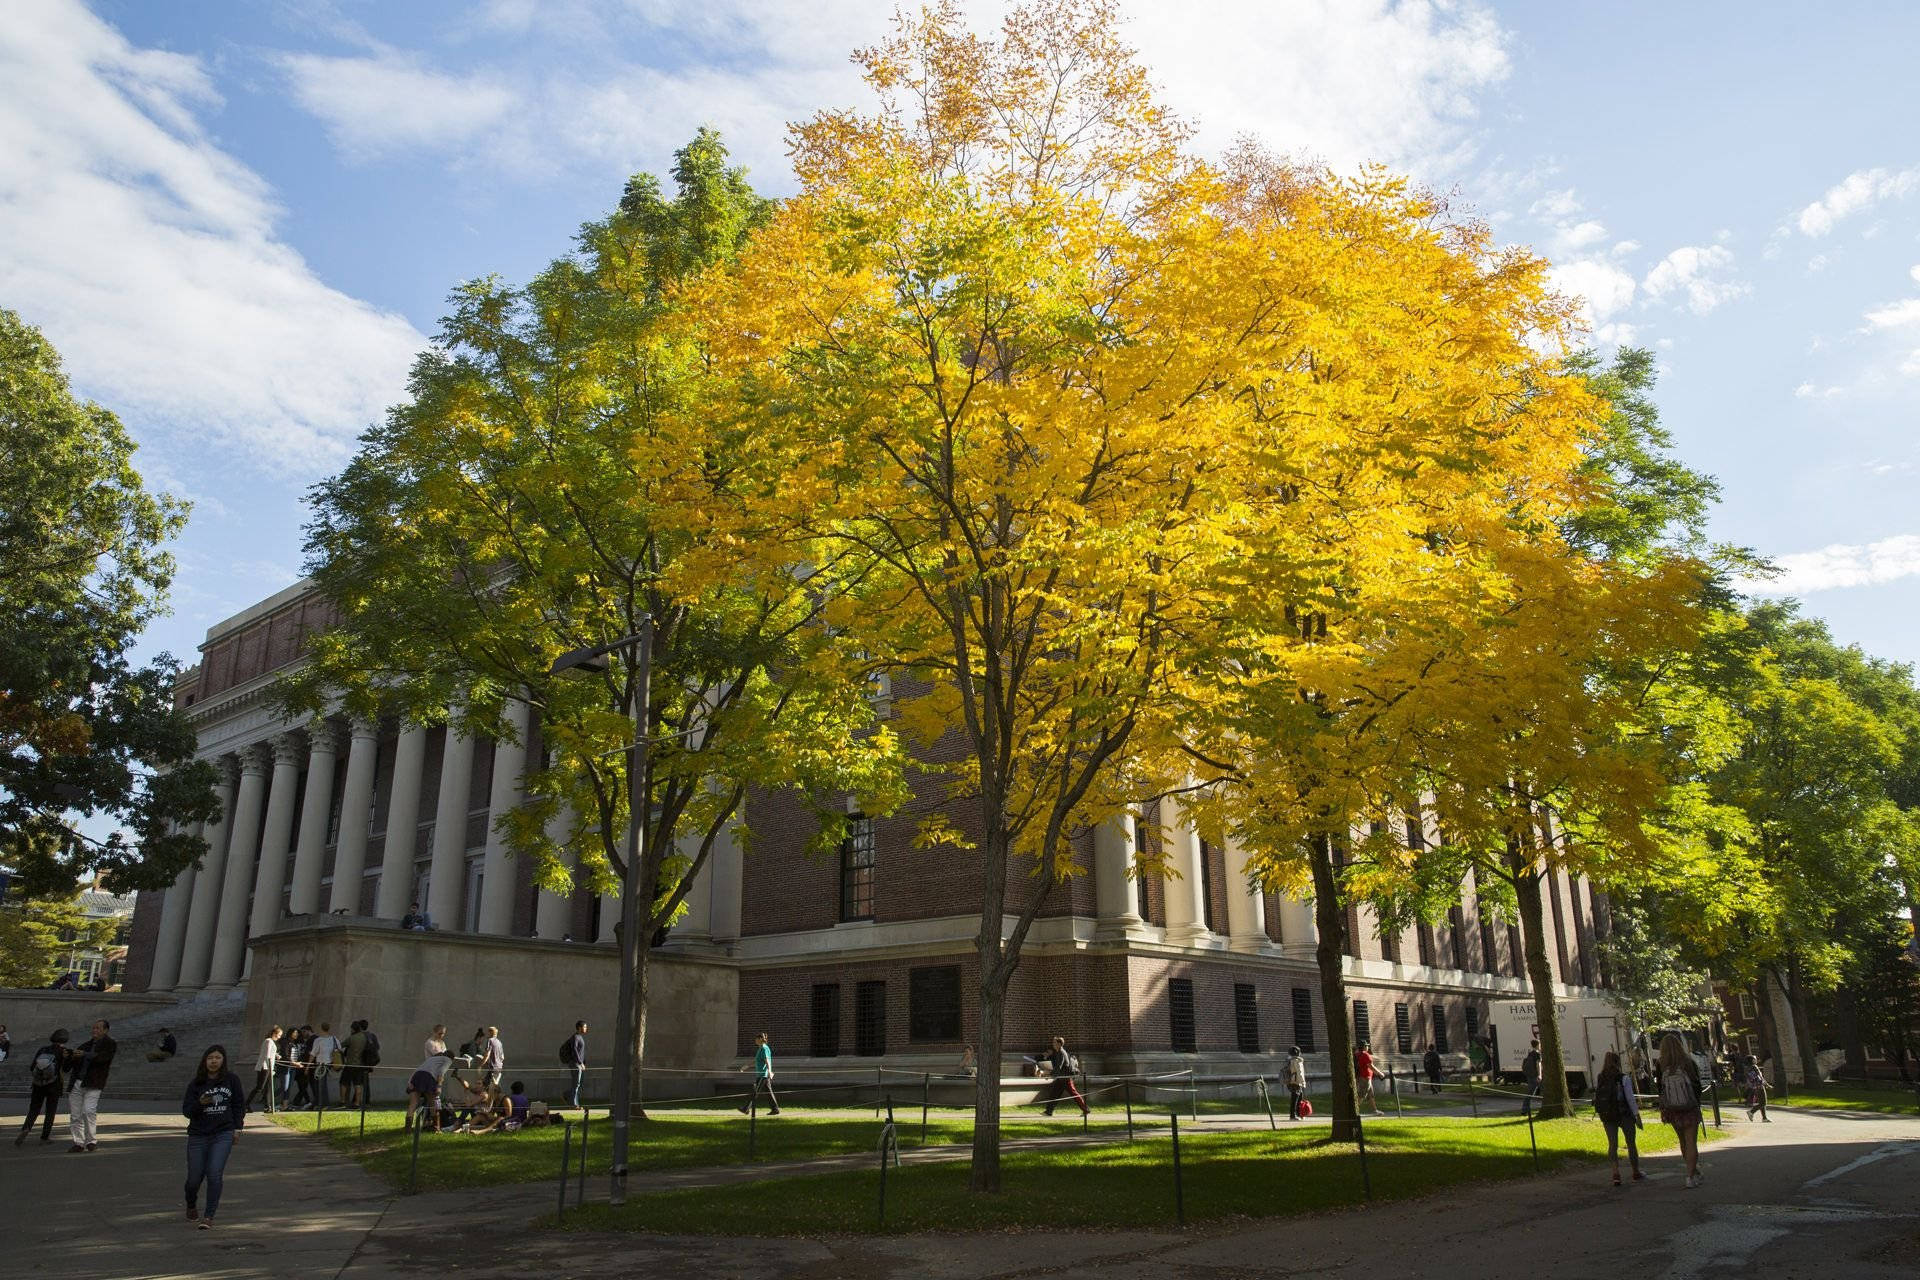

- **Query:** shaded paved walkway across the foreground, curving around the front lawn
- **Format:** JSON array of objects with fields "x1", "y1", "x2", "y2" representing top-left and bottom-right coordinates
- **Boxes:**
[{"x1": 0, "y1": 1109, "x2": 1920, "y2": 1280}]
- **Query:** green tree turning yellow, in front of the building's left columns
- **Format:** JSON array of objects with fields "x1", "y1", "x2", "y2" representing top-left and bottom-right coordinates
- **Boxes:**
[{"x1": 286, "y1": 130, "x2": 900, "y2": 1105}]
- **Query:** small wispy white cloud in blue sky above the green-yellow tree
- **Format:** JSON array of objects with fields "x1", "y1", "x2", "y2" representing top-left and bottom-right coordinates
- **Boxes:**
[{"x1": 276, "y1": 48, "x2": 518, "y2": 159}]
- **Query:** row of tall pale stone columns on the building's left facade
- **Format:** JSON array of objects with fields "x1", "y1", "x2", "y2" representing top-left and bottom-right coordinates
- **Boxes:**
[{"x1": 150, "y1": 700, "x2": 691, "y2": 990}]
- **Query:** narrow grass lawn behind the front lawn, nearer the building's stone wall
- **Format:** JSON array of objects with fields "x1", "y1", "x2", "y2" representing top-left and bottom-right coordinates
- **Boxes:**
[{"x1": 273, "y1": 1107, "x2": 1121, "y2": 1190}]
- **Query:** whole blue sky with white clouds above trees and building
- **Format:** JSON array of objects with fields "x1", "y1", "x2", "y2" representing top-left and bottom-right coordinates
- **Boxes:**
[{"x1": 0, "y1": 0, "x2": 1920, "y2": 660}]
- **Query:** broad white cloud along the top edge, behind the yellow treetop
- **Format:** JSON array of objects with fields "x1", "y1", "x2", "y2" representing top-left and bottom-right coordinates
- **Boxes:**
[{"x1": 282, "y1": 0, "x2": 1509, "y2": 182}]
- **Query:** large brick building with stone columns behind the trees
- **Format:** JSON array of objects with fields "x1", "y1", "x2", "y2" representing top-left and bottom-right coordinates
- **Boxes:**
[{"x1": 127, "y1": 583, "x2": 1605, "y2": 1071}]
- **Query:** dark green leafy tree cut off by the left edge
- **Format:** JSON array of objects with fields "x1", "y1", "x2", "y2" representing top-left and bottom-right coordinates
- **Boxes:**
[{"x1": 0, "y1": 311, "x2": 215, "y2": 894}]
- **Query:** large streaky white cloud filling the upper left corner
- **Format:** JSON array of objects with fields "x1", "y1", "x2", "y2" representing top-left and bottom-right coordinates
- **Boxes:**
[{"x1": 0, "y1": 0, "x2": 424, "y2": 474}]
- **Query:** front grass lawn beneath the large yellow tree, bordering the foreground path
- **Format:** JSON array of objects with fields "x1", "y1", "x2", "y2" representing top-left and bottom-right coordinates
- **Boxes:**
[{"x1": 564, "y1": 1117, "x2": 1715, "y2": 1236}]
